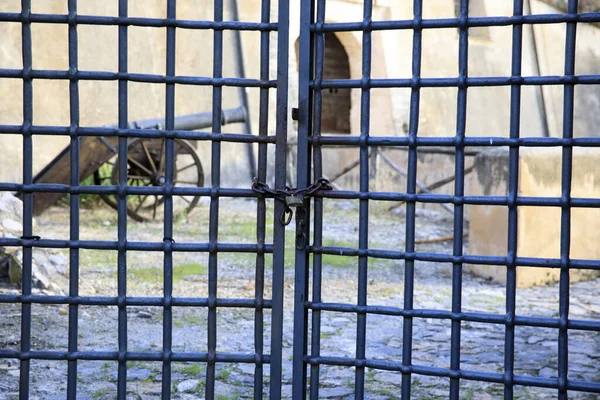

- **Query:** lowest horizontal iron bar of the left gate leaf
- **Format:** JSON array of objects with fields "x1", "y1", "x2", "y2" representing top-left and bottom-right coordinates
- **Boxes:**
[{"x1": 0, "y1": 350, "x2": 271, "y2": 364}]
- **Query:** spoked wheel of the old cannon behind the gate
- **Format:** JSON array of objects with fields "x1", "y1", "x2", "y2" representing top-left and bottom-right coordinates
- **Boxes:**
[{"x1": 94, "y1": 138, "x2": 204, "y2": 222}]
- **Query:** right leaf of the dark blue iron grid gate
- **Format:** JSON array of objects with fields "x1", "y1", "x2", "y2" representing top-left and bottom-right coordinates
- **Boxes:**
[{"x1": 293, "y1": 0, "x2": 600, "y2": 399}]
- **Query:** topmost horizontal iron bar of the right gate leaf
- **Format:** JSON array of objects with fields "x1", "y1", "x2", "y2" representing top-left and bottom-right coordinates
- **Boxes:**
[{"x1": 310, "y1": 12, "x2": 600, "y2": 33}]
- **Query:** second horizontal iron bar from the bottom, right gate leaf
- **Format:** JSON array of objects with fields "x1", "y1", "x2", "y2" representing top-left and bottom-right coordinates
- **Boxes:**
[{"x1": 304, "y1": 301, "x2": 600, "y2": 332}]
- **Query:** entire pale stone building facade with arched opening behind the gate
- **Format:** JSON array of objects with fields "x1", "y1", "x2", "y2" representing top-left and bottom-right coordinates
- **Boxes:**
[{"x1": 0, "y1": 0, "x2": 600, "y2": 189}]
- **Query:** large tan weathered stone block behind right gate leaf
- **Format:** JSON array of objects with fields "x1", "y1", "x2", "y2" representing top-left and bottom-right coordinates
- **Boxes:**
[{"x1": 467, "y1": 148, "x2": 600, "y2": 287}]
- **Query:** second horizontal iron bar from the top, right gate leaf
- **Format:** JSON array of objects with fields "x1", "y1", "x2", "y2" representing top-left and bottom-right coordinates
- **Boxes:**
[{"x1": 310, "y1": 75, "x2": 600, "y2": 90}]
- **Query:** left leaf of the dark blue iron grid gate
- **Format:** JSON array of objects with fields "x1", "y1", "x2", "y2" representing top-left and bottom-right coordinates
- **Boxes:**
[{"x1": 0, "y1": 0, "x2": 288, "y2": 399}]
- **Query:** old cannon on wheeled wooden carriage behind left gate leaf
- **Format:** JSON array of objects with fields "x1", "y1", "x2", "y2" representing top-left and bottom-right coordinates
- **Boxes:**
[{"x1": 33, "y1": 108, "x2": 246, "y2": 221}]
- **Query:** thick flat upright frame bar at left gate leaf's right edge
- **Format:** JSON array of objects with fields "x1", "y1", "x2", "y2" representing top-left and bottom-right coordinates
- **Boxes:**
[{"x1": 270, "y1": 0, "x2": 290, "y2": 400}]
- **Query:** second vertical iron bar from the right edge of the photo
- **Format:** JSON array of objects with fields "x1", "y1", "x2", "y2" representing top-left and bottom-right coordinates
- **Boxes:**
[{"x1": 504, "y1": 0, "x2": 523, "y2": 399}]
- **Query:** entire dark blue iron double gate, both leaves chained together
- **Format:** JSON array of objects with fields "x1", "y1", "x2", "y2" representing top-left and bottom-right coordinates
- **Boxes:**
[{"x1": 0, "y1": 0, "x2": 600, "y2": 399}]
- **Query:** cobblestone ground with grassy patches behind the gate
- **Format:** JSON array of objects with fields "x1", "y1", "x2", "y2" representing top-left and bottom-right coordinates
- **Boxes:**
[{"x1": 0, "y1": 200, "x2": 600, "y2": 399}]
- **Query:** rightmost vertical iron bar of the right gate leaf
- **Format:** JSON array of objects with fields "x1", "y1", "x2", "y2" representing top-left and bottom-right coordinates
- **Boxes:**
[{"x1": 558, "y1": 0, "x2": 578, "y2": 400}]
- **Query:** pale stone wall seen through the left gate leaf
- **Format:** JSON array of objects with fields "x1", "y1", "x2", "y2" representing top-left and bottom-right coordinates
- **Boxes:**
[{"x1": 0, "y1": 0, "x2": 277, "y2": 186}]
